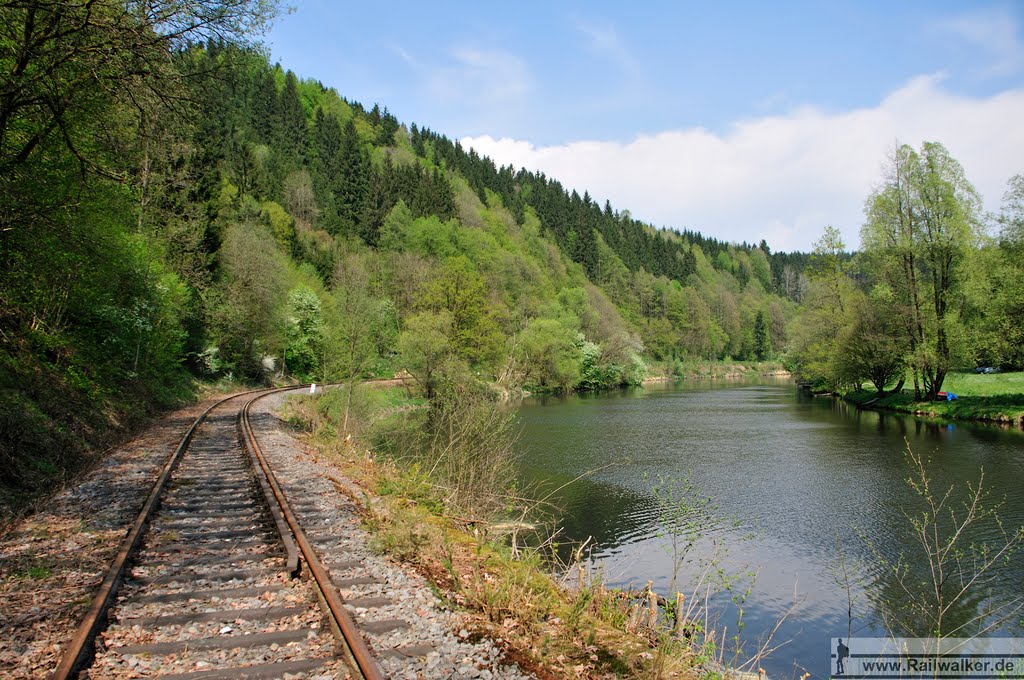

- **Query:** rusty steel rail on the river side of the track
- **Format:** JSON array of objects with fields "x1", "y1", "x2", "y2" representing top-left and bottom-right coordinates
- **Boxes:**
[{"x1": 242, "y1": 388, "x2": 384, "y2": 680}]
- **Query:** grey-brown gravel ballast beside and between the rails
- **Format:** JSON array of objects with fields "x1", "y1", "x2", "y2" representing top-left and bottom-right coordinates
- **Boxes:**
[{"x1": 0, "y1": 394, "x2": 534, "y2": 678}]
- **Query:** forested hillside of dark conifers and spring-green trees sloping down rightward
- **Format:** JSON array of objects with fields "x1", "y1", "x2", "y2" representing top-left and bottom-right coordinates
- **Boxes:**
[{"x1": 0, "y1": 0, "x2": 807, "y2": 516}]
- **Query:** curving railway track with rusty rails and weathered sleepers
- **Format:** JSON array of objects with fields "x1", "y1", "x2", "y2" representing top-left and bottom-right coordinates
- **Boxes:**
[{"x1": 53, "y1": 388, "x2": 385, "y2": 680}]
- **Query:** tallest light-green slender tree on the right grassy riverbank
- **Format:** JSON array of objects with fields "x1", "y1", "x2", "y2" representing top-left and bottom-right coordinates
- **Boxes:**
[{"x1": 861, "y1": 141, "x2": 982, "y2": 399}]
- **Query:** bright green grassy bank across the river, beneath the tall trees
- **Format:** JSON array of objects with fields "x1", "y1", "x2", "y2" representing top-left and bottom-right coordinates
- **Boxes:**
[{"x1": 844, "y1": 372, "x2": 1024, "y2": 428}]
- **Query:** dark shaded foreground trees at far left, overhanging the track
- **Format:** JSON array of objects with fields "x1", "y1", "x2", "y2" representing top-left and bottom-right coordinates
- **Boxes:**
[{"x1": 0, "y1": 0, "x2": 284, "y2": 506}]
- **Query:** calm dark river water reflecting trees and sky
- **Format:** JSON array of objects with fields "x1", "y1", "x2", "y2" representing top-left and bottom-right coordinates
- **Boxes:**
[{"x1": 519, "y1": 378, "x2": 1024, "y2": 677}]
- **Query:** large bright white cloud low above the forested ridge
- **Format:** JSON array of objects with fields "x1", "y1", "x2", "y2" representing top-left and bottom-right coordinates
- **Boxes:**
[{"x1": 462, "y1": 76, "x2": 1024, "y2": 250}]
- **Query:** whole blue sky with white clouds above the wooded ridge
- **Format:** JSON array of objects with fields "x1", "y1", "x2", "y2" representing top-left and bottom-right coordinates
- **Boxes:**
[{"x1": 267, "y1": 2, "x2": 1024, "y2": 249}]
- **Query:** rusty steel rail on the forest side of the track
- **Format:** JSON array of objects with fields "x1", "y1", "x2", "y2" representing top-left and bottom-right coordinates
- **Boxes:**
[{"x1": 50, "y1": 390, "x2": 261, "y2": 680}]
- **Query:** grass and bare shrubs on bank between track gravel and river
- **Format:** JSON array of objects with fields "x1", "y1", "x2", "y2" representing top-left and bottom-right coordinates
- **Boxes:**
[{"x1": 281, "y1": 383, "x2": 770, "y2": 678}]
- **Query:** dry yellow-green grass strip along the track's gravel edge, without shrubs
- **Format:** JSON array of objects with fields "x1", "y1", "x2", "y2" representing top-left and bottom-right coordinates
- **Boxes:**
[{"x1": 285, "y1": 388, "x2": 745, "y2": 678}]
